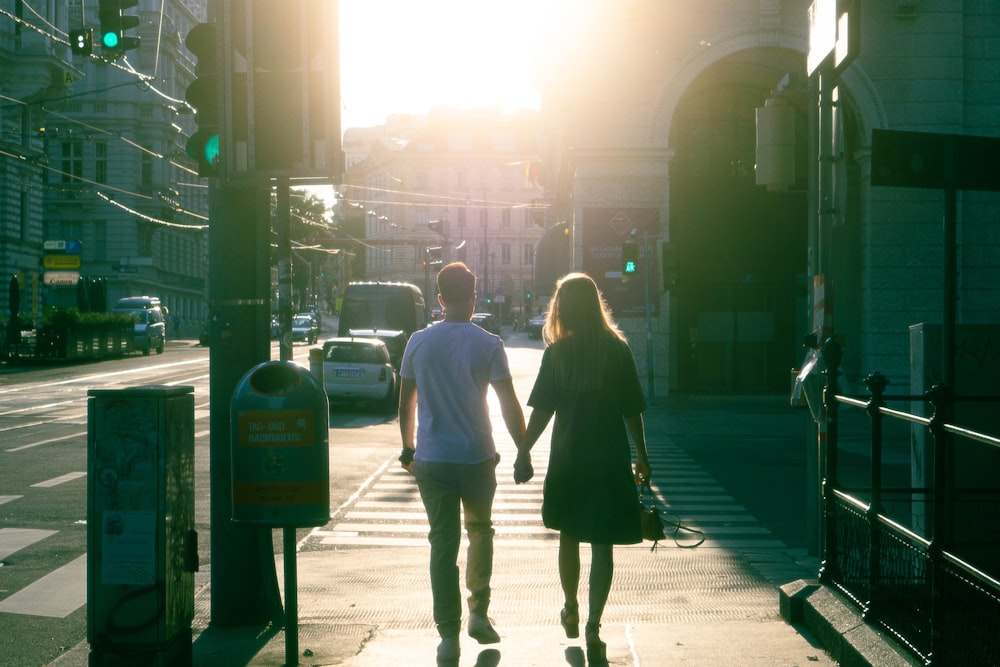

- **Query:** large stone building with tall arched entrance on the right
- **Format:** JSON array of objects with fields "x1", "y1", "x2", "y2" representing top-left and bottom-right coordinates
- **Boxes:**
[{"x1": 539, "y1": 0, "x2": 1000, "y2": 396}]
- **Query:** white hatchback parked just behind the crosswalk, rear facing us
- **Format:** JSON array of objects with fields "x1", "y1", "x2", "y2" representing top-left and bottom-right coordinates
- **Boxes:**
[{"x1": 323, "y1": 337, "x2": 399, "y2": 412}]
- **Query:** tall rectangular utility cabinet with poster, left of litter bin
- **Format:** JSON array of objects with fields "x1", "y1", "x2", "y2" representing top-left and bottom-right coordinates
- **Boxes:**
[{"x1": 87, "y1": 386, "x2": 198, "y2": 667}]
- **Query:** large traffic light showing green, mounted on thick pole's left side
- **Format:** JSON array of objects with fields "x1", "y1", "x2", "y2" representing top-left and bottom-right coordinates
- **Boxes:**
[{"x1": 184, "y1": 23, "x2": 221, "y2": 178}]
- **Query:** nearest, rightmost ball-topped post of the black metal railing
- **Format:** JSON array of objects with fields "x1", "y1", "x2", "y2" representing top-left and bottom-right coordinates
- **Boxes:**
[{"x1": 926, "y1": 382, "x2": 954, "y2": 665}]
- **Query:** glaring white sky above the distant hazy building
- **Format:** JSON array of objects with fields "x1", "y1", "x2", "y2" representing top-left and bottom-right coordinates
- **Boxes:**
[{"x1": 340, "y1": 0, "x2": 573, "y2": 129}]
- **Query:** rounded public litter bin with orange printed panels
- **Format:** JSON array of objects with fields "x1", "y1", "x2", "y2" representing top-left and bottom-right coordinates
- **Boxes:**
[{"x1": 232, "y1": 361, "x2": 330, "y2": 528}]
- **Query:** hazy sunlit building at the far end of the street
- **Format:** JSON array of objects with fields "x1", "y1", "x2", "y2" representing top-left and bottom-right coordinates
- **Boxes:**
[{"x1": 341, "y1": 110, "x2": 548, "y2": 321}]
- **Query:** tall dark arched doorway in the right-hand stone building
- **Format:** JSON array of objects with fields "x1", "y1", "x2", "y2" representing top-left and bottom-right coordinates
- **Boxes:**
[{"x1": 670, "y1": 52, "x2": 808, "y2": 393}]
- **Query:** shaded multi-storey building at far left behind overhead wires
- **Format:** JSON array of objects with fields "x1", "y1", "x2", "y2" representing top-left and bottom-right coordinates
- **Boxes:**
[{"x1": 0, "y1": 0, "x2": 208, "y2": 335}]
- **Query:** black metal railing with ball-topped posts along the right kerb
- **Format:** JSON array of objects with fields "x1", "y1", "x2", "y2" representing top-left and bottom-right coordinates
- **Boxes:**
[{"x1": 820, "y1": 340, "x2": 1000, "y2": 667}]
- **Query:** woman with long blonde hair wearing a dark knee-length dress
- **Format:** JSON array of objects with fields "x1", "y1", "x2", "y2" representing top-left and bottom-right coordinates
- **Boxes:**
[{"x1": 514, "y1": 273, "x2": 650, "y2": 663}]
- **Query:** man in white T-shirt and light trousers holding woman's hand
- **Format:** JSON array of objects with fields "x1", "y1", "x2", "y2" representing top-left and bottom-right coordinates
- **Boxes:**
[{"x1": 399, "y1": 262, "x2": 525, "y2": 664}]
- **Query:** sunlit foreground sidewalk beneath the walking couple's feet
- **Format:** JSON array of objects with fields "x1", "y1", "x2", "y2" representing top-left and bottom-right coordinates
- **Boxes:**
[{"x1": 51, "y1": 388, "x2": 916, "y2": 667}]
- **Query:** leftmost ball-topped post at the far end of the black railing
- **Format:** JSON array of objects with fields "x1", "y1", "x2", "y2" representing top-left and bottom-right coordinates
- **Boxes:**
[{"x1": 819, "y1": 338, "x2": 844, "y2": 581}]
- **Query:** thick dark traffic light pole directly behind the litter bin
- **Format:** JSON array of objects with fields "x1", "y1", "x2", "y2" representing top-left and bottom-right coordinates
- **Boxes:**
[{"x1": 208, "y1": 180, "x2": 281, "y2": 627}]
